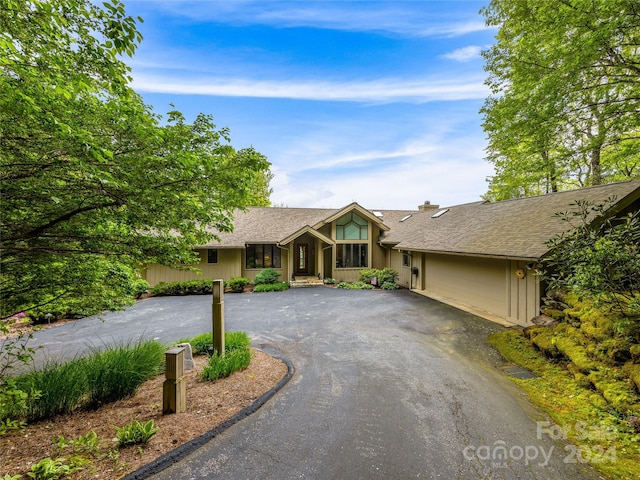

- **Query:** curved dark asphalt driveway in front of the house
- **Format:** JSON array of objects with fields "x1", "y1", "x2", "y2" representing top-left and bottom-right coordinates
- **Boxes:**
[{"x1": 27, "y1": 288, "x2": 600, "y2": 480}]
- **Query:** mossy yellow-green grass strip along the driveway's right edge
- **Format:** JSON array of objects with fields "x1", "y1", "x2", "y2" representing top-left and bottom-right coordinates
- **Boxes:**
[{"x1": 489, "y1": 330, "x2": 640, "y2": 480}]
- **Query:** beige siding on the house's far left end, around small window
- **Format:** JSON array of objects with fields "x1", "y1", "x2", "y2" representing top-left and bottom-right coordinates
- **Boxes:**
[{"x1": 143, "y1": 249, "x2": 242, "y2": 287}]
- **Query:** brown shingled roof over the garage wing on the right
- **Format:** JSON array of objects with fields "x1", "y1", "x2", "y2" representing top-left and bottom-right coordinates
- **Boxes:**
[{"x1": 382, "y1": 180, "x2": 640, "y2": 260}]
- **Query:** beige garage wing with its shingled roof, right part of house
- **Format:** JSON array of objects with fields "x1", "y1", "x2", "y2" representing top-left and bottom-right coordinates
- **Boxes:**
[{"x1": 380, "y1": 180, "x2": 640, "y2": 326}]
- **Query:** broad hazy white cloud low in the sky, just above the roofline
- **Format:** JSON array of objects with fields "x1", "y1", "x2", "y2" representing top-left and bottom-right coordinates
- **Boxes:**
[{"x1": 272, "y1": 128, "x2": 492, "y2": 209}]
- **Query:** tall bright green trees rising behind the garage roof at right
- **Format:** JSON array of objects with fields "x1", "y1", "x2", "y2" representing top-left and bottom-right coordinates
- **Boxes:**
[{"x1": 481, "y1": 0, "x2": 640, "y2": 199}]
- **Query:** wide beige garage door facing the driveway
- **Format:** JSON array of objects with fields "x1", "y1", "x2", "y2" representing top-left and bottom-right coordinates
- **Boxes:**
[{"x1": 423, "y1": 254, "x2": 509, "y2": 319}]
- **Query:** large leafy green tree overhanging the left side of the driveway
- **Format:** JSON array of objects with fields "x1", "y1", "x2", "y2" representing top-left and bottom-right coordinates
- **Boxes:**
[{"x1": 0, "y1": 0, "x2": 270, "y2": 318}]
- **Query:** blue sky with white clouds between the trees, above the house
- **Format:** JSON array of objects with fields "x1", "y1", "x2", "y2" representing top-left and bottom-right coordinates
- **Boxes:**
[{"x1": 124, "y1": 0, "x2": 496, "y2": 209}]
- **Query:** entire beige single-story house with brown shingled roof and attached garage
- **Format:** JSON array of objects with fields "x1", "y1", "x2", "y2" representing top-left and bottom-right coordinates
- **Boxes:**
[{"x1": 143, "y1": 180, "x2": 640, "y2": 326}]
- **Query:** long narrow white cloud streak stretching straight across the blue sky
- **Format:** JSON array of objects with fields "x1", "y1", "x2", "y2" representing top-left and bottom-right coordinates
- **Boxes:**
[{"x1": 133, "y1": 73, "x2": 488, "y2": 103}]
